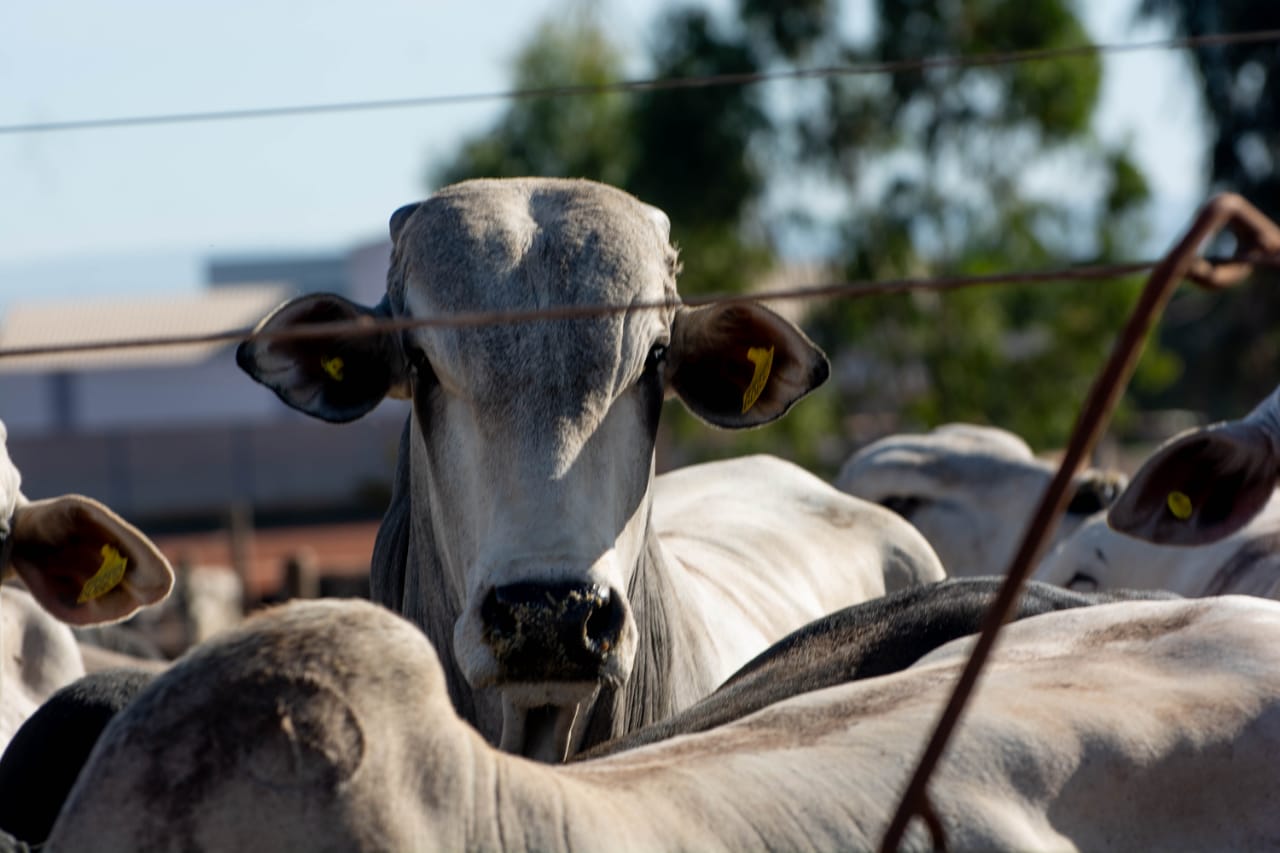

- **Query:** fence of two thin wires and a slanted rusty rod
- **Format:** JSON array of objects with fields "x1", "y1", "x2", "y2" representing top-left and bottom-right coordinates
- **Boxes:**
[{"x1": 0, "y1": 23, "x2": 1280, "y2": 850}]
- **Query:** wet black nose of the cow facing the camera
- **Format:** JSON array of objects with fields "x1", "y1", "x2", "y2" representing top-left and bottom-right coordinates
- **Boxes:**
[{"x1": 480, "y1": 583, "x2": 625, "y2": 681}]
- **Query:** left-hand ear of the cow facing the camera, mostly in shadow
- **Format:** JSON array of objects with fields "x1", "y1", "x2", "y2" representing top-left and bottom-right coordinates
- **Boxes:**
[{"x1": 236, "y1": 293, "x2": 408, "y2": 423}]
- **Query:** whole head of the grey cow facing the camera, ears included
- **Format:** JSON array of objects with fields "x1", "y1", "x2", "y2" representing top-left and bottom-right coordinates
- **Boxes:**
[{"x1": 238, "y1": 179, "x2": 828, "y2": 747}]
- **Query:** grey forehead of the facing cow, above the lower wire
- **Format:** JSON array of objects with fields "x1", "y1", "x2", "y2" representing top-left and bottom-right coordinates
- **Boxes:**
[{"x1": 388, "y1": 178, "x2": 678, "y2": 313}]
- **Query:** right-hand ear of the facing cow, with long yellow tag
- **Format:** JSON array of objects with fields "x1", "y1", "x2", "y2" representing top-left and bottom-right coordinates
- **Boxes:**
[{"x1": 667, "y1": 304, "x2": 831, "y2": 429}]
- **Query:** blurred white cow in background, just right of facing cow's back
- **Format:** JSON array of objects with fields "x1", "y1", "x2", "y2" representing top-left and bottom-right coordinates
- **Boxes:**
[{"x1": 836, "y1": 424, "x2": 1125, "y2": 578}]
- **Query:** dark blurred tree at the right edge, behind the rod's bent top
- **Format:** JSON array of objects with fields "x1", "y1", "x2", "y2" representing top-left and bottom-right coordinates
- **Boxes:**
[{"x1": 1140, "y1": 0, "x2": 1280, "y2": 419}]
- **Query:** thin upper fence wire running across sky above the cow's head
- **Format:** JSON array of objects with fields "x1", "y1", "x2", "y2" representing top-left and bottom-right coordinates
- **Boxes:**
[{"x1": 0, "y1": 29, "x2": 1280, "y2": 136}]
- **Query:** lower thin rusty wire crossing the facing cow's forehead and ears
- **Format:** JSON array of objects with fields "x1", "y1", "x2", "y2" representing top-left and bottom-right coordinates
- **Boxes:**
[{"x1": 0, "y1": 252, "x2": 1208, "y2": 360}]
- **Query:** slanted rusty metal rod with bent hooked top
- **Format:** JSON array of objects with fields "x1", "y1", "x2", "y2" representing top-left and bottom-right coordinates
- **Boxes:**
[{"x1": 881, "y1": 193, "x2": 1280, "y2": 852}]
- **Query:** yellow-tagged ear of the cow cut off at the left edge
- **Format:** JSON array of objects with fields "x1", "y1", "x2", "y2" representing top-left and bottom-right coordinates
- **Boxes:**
[{"x1": 10, "y1": 494, "x2": 173, "y2": 625}]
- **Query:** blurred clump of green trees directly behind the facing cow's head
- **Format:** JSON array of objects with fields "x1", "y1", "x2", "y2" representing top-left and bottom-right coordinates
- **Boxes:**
[{"x1": 430, "y1": 0, "x2": 1176, "y2": 470}]
